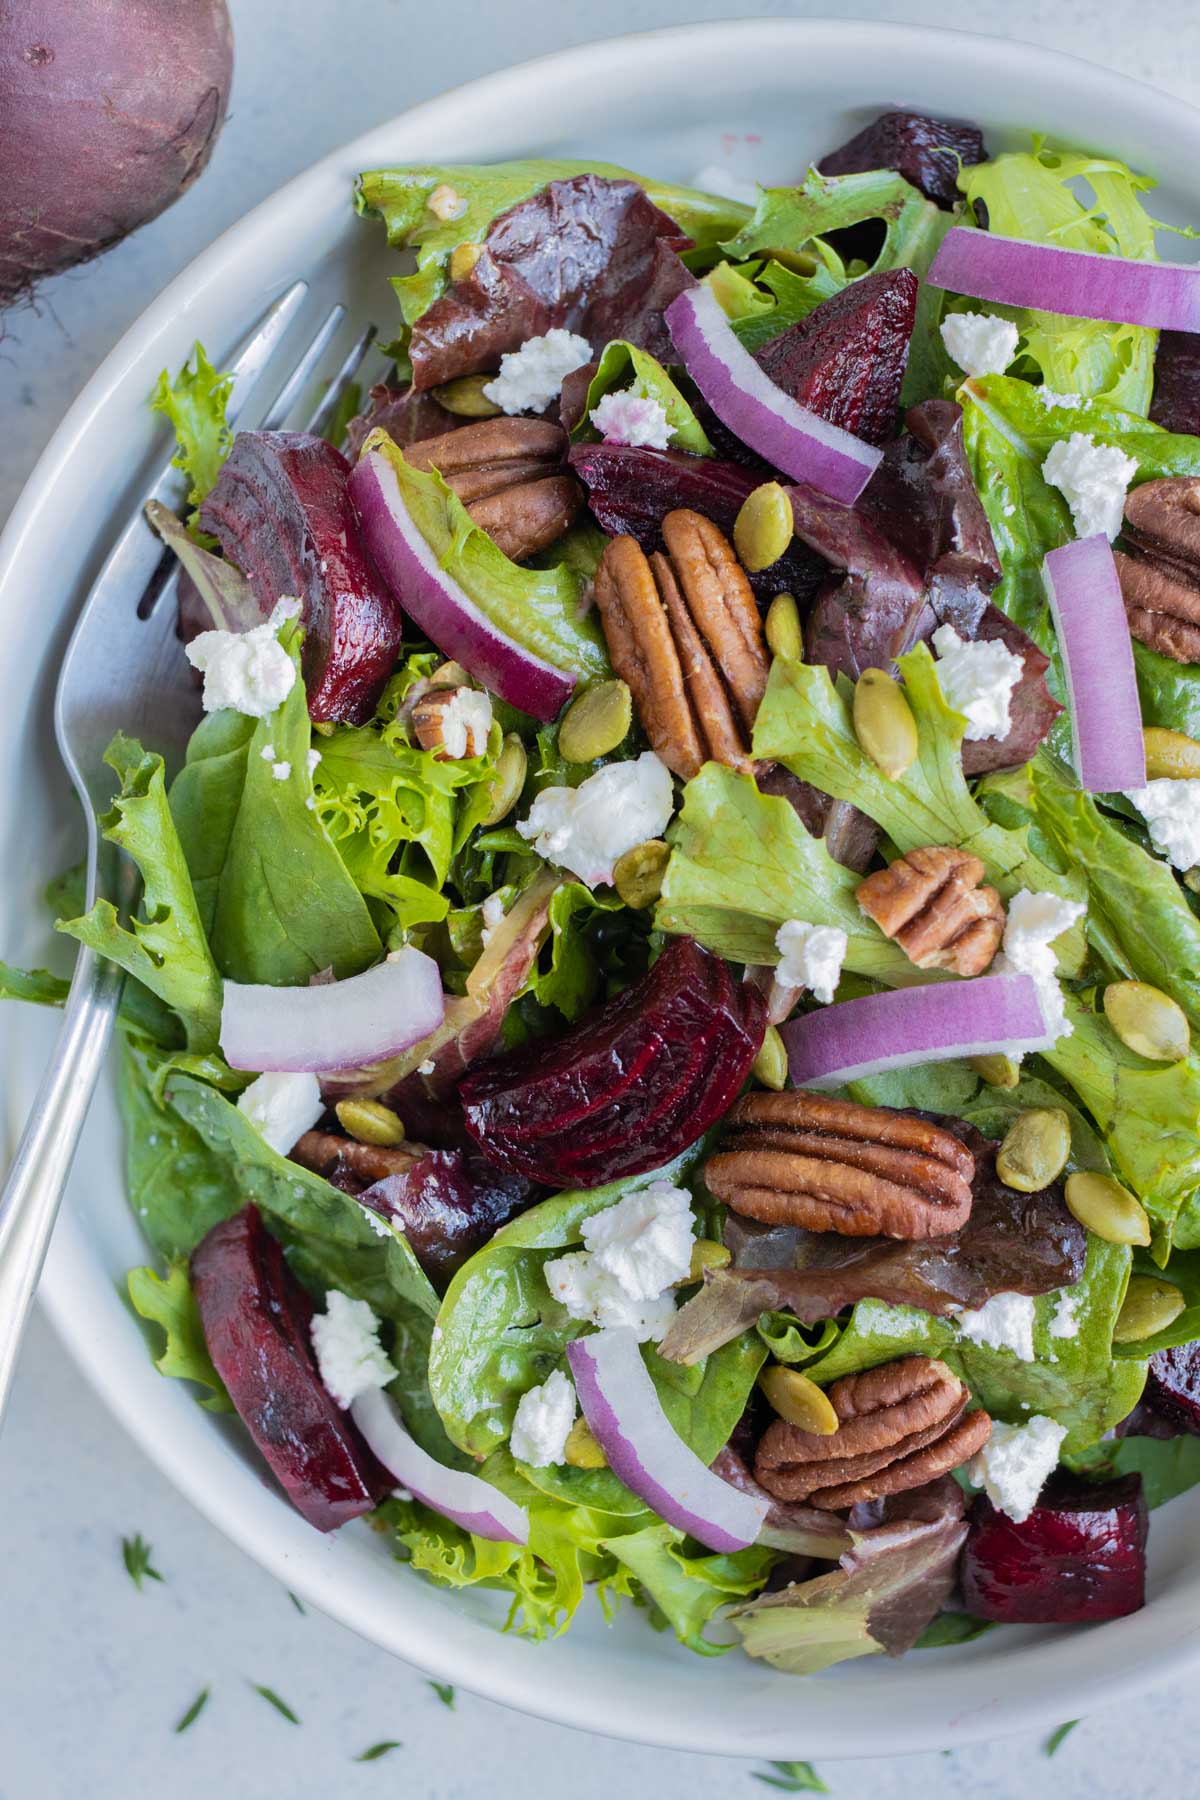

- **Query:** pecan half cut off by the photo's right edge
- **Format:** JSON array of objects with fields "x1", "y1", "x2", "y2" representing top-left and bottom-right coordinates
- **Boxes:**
[{"x1": 1114, "y1": 475, "x2": 1200, "y2": 662}]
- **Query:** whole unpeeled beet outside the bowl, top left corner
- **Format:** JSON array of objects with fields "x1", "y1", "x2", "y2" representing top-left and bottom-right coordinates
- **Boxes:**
[{"x1": 0, "y1": 0, "x2": 234, "y2": 306}]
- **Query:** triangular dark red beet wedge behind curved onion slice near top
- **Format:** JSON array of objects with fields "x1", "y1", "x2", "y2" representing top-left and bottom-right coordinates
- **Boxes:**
[{"x1": 754, "y1": 268, "x2": 919, "y2": 445}]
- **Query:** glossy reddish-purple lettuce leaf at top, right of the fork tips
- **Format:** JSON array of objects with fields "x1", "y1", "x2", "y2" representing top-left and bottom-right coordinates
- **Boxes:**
[{"x1": 408, "y1": 175, "x2": 693, "y2": 391}]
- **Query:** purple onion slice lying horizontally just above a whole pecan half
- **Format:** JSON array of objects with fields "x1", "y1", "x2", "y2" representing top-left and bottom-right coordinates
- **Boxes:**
[{"x1": 781, "y1": 976, "x2": 1056, "y2": 1087}]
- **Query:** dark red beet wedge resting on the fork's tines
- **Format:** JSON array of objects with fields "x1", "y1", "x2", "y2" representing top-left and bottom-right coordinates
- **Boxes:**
[{"x1": 200, "y1": 432, "x2": 403, "y2": 724}]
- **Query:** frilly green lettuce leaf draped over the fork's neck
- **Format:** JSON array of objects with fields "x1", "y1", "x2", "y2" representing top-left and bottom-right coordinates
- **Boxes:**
[{"x1": 58, "y1": 734, "x2": 221, "y2": 1051}]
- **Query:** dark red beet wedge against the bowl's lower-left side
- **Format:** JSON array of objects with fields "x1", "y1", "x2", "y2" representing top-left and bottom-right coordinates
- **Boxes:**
[{"x1": 191, "y1": 1206, "x2": 394, "y2": 1532}]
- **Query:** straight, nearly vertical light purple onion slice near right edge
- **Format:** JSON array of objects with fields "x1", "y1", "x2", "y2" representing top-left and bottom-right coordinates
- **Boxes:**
[{"x1": 1042, "y1": 533, "x2": 1146, "y2": 794}]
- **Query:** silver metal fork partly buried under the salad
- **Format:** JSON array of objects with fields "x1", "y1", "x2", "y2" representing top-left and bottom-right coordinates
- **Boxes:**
[{"x1": 0, "y1": 281, "x2": 374, "y2": 1422}]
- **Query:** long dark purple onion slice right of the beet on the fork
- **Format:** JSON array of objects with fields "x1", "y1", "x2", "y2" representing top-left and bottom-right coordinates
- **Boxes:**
[{"x1": 351, "y1": 450, "x2": 576, "y2": 720}]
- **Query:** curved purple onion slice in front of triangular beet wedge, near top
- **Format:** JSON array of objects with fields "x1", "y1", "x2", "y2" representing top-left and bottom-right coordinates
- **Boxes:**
[{"x1": 666, "y1": 283, "x2": 883, "y2": 506}]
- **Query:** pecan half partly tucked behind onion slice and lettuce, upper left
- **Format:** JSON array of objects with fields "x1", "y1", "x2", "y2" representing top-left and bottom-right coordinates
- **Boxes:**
[{"x1": 405, "y1": 418, "x2": 583, "y2": 562}]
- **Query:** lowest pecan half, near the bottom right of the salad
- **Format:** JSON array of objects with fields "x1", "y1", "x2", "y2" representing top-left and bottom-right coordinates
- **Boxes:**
[{"x1": 754, "y1": 1355, "x2": 991, "y2": 1512}]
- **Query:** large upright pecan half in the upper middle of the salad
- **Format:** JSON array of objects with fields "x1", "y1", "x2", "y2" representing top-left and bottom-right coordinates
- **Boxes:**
[{"x1": 596, "y1": 509, "x2": 768, "y2": 781}]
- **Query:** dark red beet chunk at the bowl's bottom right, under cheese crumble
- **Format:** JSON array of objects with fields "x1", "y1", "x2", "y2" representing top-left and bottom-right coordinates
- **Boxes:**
[{"x1": 961, "y1": 1472, "x2": 1148, "y2": 1625}]
